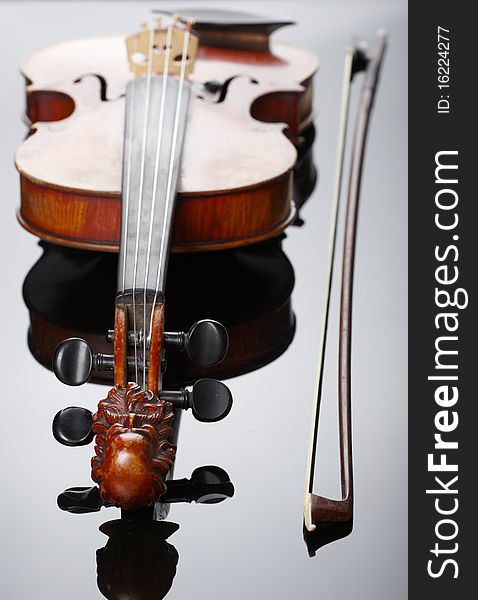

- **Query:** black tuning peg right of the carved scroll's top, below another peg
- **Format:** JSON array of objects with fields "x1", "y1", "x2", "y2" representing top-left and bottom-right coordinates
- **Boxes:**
[{"x1": 159, "y1": 379, "x2": 232, "y2": 423}]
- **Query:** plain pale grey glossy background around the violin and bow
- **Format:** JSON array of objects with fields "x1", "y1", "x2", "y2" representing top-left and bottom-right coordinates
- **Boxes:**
[{"x1": 0, "y1": 0, "x2": 407, "y2": 600}]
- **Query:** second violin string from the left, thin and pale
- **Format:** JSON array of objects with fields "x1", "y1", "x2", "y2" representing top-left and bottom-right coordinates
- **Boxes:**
[{"x1": 143, "y1": 25, "x2": 173, "y2": 382}]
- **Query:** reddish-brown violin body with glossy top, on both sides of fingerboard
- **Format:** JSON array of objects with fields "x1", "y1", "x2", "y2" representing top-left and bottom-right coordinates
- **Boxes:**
[{"x1": 16, "y1": 29, "x2": 318, "y2": 252}]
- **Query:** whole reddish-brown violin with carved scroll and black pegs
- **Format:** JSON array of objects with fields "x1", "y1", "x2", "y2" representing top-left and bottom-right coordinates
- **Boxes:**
[{"x1": 16, "y1": 11, "x2": 317, "y2": 512}]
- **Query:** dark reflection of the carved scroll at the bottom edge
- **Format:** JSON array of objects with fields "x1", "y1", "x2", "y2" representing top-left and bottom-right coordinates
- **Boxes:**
[{"x1": 96, "y1": 519, "x2": 179, "y2": 600}]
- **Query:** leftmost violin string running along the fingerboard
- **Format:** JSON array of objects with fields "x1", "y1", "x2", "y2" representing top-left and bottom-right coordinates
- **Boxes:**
[{"x1": 133, "y1": 28, "x2": 154, "y2": 387}]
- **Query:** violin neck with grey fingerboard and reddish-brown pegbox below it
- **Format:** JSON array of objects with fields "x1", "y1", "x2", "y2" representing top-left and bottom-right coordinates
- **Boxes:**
[{"x1": 115, "y1": 75, "x2": 190, "y2": 392}]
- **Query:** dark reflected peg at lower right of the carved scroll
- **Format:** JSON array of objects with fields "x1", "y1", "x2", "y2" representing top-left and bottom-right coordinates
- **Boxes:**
[{"x1": 161, "y1": 466, "x2": 234, "y2": 504}]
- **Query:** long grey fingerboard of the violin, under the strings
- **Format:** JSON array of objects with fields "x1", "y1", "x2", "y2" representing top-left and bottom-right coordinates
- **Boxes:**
[{"x1": 118, "y1": 76, "x2": 190, "y2": 300}]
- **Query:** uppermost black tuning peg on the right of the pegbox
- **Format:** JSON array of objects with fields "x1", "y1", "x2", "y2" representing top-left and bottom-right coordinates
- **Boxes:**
[{"x1": 164, "y1": 319, "x2": 229, "y2": 367}]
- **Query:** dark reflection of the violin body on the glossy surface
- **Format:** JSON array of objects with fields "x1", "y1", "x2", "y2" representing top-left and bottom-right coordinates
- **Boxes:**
[{"x1": 23, "y1": 239, "x2": 295, "y2": 386}]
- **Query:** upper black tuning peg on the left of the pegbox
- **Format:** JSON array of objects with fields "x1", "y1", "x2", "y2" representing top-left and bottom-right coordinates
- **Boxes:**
[{"x1": 52, "y1": 338, "x2": 114, "y2": 385}]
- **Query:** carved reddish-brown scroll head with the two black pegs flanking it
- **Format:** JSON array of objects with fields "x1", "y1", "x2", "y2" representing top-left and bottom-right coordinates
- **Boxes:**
[{"x1": 53, "y1": 379, "x2": 232, "y2": 510}]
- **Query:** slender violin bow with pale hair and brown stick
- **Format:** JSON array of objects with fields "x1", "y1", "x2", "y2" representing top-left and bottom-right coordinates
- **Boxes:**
[{"x1": 304, "y1": 31, "x2": 387, "y2": 540}]
